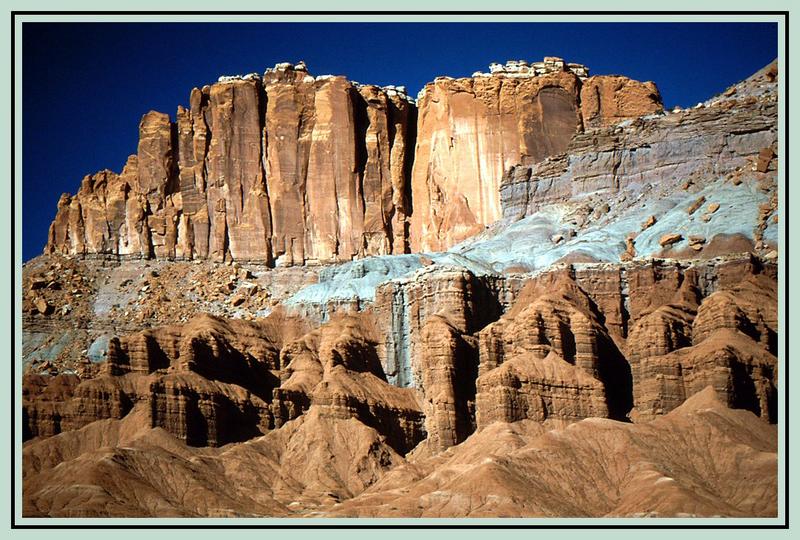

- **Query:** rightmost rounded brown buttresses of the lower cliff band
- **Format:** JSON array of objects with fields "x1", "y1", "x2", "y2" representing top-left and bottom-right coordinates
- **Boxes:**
[{"x1": 628, "y1": 263, "x2": 778, "y2": 422}]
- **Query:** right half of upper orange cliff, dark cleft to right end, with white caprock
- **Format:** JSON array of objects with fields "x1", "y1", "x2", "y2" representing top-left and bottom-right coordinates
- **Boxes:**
[{"x1": 410, "y1": 58, "x2": 662, "y2": 251}]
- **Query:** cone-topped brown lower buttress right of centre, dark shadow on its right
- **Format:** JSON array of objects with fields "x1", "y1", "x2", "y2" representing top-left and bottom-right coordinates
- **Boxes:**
[{"x1": 476, "y1": 273, "x2": 631, "y2": 426}]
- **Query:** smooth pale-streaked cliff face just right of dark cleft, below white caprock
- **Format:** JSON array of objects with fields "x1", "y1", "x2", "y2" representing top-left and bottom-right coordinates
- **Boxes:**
[{"x1": 411, "y1": 63, "x2": 580, "y2": 251}]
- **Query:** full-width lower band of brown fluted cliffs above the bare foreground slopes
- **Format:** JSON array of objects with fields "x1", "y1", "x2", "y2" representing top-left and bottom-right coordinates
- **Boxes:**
[{"x1": 23, "y1": 257, "x2": 778, "y2": 455}]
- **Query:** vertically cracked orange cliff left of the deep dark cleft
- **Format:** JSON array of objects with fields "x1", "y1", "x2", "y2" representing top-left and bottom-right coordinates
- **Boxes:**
[{"x1": 46, "y1": 64, "x2": 416, "y2": 265}]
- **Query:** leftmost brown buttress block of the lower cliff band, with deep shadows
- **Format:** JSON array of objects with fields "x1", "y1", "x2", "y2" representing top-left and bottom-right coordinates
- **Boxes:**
[{"x1": 23, "y1": 315, "x2": 306, "y2": 446}]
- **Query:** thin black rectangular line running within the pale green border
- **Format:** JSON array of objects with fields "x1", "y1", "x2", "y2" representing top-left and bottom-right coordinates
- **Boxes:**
[{"x1": 9, "y1": 10, "x2": 790, "y2": 529}]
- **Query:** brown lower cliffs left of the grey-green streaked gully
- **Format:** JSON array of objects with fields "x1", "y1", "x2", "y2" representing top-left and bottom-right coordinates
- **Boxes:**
[{"x1": 23, "y1": 313, "x2": 425, "y2": 453}]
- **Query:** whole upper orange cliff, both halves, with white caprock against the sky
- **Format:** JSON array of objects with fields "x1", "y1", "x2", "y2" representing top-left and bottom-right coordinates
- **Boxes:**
[{"x1": 46, "y1": 58, "x2": 662, "y2": 265}]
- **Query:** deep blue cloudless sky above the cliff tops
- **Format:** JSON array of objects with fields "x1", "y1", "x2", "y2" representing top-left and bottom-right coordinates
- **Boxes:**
[{"x1": 22, "y1": 23, "x2": 778, "y2": 260}]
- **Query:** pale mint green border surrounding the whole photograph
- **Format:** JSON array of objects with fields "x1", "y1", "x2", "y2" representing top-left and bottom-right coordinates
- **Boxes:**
[{"x1": 0, "y1": 4, "x2": 800, "y2": 538}]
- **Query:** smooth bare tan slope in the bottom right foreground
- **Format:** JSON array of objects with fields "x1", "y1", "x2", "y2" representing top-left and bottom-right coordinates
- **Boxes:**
[{"x1": 324, "y1": 388, "x2": 777, "y2": 517}]
